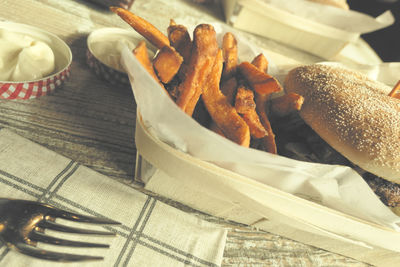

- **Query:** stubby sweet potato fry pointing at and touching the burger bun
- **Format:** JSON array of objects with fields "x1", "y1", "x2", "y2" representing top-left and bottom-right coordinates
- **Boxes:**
[{"x1": 271, "y1": 93, "x2": 304, "y2": 117}]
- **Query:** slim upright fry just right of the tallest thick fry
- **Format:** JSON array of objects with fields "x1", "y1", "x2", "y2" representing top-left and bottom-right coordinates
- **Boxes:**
[{"x1": 222, "y1": 32, "x2": 238, "y2": 79}]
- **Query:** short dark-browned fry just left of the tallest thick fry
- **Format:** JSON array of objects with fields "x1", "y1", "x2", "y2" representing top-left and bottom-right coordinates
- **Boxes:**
[{"x1": 167, "y1": 19, "x2": 192, "y2": 63}]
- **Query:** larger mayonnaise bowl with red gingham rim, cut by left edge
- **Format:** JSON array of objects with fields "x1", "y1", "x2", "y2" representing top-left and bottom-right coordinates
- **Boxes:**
[{"x1": 0, "y1": 21, "x2": 72, "y2": 99}]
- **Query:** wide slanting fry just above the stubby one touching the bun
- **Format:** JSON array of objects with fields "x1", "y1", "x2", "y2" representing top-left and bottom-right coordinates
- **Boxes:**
[{"x1": 239, "y1": 62, "x2": 282, "y2": 95}]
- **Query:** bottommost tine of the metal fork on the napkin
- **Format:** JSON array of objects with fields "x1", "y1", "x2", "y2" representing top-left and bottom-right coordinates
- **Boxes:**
[{"x1": 15, "y1": 244, "x2": 104, "y2": 262}]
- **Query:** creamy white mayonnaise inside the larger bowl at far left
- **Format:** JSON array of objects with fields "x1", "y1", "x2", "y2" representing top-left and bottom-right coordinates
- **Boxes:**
[{"x1": 0, "y1": 29, "x2": 56, "y2": 81}]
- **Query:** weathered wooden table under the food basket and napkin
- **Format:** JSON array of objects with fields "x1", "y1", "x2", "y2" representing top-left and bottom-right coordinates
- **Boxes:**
[{"x1": 0, "y1": 0, "x2": 376, "y2": 266}]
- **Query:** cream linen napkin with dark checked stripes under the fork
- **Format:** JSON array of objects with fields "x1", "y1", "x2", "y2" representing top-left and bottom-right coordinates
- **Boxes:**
[{"x1": 0, "y1": 129, "x2": 226, "y2": 267}]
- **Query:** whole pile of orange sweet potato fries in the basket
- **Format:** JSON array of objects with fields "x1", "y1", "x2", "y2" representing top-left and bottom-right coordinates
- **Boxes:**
[{"x1": 110, "y1": 7, "x2": 303, "y2": 154}]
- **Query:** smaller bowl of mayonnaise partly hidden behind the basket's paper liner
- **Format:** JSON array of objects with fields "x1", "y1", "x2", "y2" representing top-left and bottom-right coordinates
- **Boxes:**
[{"x1": 86, "y1": 28, "x2": 154, "y2": 86}]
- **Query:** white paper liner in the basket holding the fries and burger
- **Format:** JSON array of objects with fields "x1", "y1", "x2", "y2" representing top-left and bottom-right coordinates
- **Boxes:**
[{"x1": 122, "y1": 24, "x2": 400, "y2": 231}]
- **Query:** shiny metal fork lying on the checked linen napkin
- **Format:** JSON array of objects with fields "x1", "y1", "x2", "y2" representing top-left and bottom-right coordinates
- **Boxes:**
[{"x1": 0, "y1": 198, "x2": 120, "y2": 262}]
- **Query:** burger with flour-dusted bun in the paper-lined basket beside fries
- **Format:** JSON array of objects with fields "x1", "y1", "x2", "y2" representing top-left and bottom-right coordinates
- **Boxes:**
[{"x1": 272, "y1": 64, "x2": 400, "y2": 215}]
